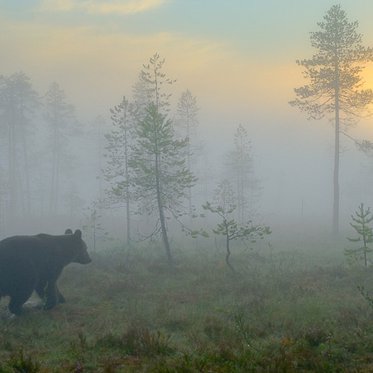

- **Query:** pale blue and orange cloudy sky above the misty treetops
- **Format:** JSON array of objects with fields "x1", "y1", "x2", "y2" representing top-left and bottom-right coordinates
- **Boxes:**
[{"x1": 0, "y1": 0, "x2": 373, "y2": 116}]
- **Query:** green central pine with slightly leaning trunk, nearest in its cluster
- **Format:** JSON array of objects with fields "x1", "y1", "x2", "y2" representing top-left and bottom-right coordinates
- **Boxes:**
[{"x1": 129, "y1": 103, "x2": 196, "y2": 264}]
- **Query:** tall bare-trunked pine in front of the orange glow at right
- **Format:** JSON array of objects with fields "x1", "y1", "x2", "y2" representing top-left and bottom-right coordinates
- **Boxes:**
[{"x1": 290, "y1": 5, "x2": 373, "y2": 233}]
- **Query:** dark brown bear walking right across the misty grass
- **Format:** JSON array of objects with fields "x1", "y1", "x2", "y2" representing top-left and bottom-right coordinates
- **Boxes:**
[{"x1": 0, "y1": 229, "x2": 92, "y2": 315}]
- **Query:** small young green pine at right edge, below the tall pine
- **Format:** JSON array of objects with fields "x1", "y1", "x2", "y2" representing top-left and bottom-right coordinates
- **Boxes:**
[{"x1": 345, "y1": 203, "x2": 373, "y2": 267}]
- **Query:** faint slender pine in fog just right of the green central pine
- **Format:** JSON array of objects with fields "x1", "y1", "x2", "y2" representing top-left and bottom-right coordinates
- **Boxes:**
[{"x1": 177, "y1": 89, "x2": 199, "y2": 216}]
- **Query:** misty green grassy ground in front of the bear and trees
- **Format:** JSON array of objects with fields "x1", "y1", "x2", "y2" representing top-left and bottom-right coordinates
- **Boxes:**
[{"x1": 0, "y1": 234, "x2": 373, "y2": 373}]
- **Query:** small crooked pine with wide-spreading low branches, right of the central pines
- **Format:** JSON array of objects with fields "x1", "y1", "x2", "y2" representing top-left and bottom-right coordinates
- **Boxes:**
[{"x1": 202, "y1": 180, "x2": 271, "y2": 272}]
